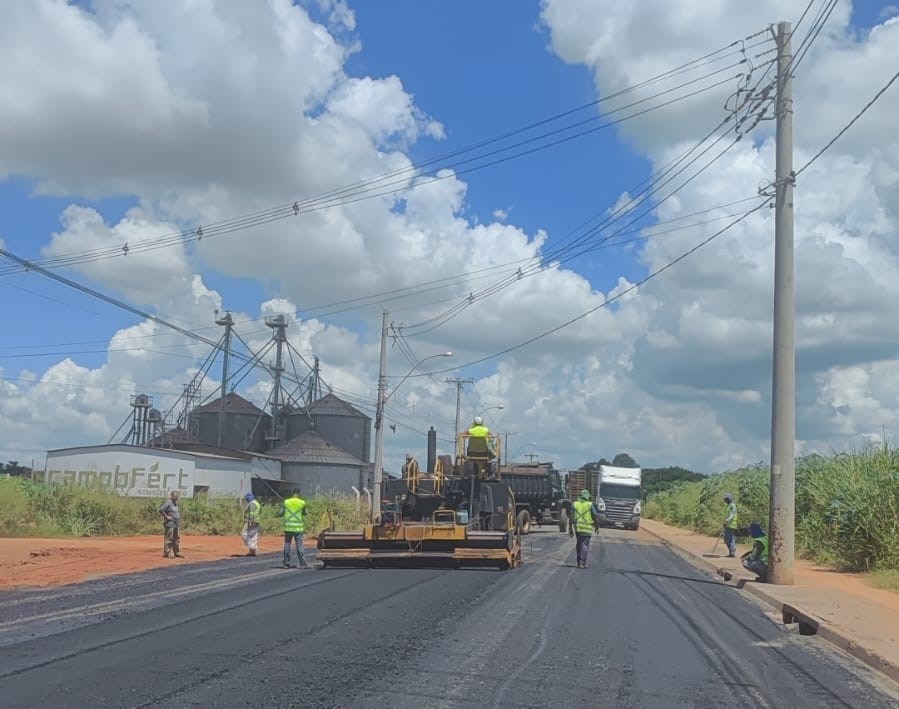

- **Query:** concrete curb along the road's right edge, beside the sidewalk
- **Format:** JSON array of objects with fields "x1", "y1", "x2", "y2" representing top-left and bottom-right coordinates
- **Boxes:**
[{"x1": 641, "y1": 525, "x2": 899, "y2": 682}]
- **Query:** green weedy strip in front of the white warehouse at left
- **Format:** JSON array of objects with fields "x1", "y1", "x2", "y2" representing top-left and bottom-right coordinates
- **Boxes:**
[{"x1": 0, "y1": 477, "x2": 364, "y2": 537}]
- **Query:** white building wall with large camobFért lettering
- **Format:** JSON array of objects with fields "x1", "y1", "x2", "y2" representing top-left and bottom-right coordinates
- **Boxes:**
[{"x1": 43, "y1": 451, "x2": 194, "y2": 497}]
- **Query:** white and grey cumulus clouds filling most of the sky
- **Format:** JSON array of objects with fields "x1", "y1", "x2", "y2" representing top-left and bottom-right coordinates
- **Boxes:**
[{"x1": 0, "y1": 0, "x2": 899, "y2": 470}]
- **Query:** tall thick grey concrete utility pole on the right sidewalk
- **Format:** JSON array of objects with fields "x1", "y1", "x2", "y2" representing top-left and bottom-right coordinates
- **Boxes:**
[{"x1": 768, "y1": 22, "x2": 796, "y2": 585}]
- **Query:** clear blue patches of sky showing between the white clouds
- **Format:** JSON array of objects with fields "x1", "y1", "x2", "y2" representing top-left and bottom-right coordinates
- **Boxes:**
[{"x1": 0, "y1": 2, "x2": 648, "y2": 375}]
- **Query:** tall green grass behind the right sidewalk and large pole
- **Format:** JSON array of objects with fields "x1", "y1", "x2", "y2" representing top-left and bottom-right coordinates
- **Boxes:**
[{"x1": 643, "y1": 445, "x2": 899, "y2": 571}]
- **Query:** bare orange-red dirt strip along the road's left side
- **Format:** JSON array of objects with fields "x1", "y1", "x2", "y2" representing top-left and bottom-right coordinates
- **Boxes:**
[{"x1": 0, "y1": 534, "x2": 315, "y2": 589}]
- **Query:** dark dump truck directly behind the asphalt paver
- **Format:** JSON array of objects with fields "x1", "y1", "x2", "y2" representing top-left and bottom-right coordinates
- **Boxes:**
[{"x1": 500, "y1": 462, "x2": 570, "y2": 534}]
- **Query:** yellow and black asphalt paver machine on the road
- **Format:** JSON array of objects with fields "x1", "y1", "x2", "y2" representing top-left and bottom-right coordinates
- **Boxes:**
[{"x1": 318, "y1": 427, "x2": 521, "y2": 570}]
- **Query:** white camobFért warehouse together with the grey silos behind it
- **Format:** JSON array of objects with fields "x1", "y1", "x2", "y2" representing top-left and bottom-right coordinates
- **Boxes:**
[{"x1": 44, "y1": 392, "x2": 372, "y2": 498}]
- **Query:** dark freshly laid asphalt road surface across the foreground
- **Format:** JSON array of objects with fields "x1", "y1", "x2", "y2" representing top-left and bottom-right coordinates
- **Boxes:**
[{"x1": 0, "y1": 528, "x2": 899, "y2": 709}]
